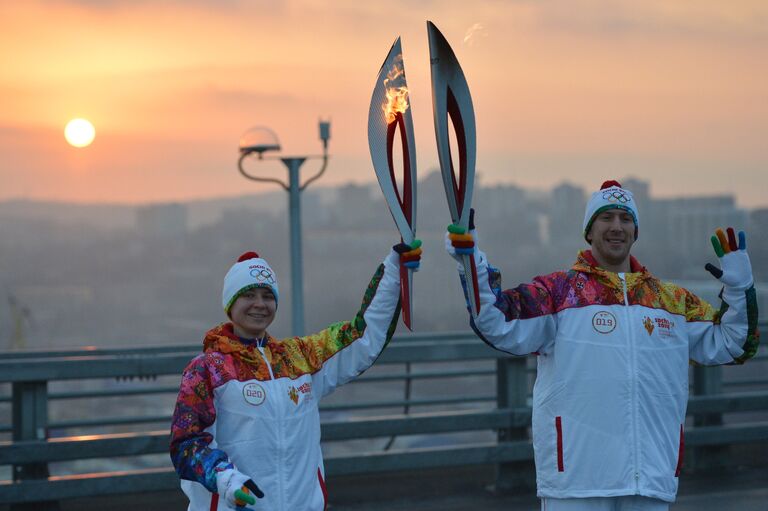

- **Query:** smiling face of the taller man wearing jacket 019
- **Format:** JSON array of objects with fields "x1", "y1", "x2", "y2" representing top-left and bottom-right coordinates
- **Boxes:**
[{"x1": 587, "y1": 209, "x2": 635, "y2": 269}]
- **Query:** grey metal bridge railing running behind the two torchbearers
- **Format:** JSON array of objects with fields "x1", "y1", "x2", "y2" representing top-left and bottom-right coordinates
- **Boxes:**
[{"x1": 0, "y1": 325, "x2": 768, "y2": 504}]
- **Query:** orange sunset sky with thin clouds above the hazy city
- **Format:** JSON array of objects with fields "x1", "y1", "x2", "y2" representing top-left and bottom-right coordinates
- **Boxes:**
[{"x1": 0, "y1": 0, "x2": 768, "y2": 207}]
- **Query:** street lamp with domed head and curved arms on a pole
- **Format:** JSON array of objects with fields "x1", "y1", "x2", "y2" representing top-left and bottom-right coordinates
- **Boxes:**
[{"x1": 237, "y1": 121, "x2": 331, "y2": 335}]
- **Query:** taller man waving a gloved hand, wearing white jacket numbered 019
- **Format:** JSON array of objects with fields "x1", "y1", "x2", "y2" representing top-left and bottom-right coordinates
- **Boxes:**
[{"x1": 446, "y1": 181, "x2": 759, "y2": 511}]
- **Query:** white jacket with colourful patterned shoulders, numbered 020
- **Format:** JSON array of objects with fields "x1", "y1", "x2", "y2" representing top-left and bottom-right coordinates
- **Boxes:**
[{"x1": 170, "y1": 252, "x2": 400, "y2": 511}]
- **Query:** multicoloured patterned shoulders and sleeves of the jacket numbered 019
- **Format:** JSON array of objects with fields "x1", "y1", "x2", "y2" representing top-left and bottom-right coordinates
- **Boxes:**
[{"x1": 468, "y1": 250, "x2": 759, "y2": 365}]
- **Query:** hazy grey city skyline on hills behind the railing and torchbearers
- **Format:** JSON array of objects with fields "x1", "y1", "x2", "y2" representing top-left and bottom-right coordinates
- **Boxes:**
[{"x1": 0, "y1": 172, "x2": 768, "y2": 350}]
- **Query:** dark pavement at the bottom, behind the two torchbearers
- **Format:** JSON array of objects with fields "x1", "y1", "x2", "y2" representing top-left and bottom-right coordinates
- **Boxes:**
[{"x1": 21, "y1": 459, "x2": 768, "y2": 511}]
